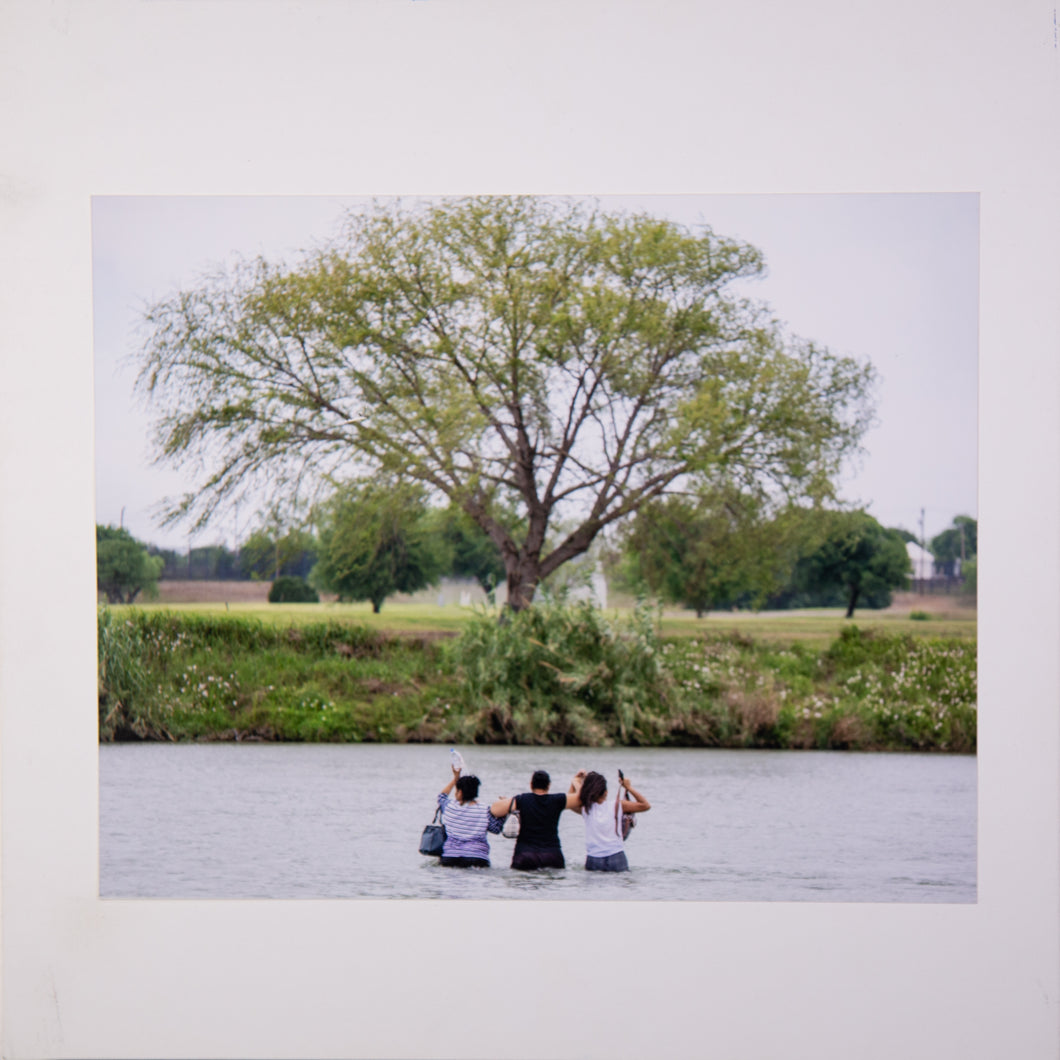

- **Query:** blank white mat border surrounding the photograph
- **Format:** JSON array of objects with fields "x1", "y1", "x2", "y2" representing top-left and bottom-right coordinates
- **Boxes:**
[{"x1": 0, "y1": 0, "x2": 1060, "y2": 1060}]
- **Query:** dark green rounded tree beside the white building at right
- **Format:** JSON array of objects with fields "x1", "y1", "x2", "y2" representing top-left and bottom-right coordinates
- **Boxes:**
[{"x1": 794, "y1": 511, "x2": 912, "y2": 618}]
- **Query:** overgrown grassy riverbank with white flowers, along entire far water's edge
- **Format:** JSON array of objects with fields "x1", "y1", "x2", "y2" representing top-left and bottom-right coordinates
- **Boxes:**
[{"x1": 99, "y1": 607, "x2": 975, "y2": 753}]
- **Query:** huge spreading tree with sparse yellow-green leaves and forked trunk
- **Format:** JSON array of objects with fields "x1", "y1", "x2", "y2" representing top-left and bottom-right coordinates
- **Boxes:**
[{"x1": 140, "y1": 197, "x2": 871, "y2": 608}]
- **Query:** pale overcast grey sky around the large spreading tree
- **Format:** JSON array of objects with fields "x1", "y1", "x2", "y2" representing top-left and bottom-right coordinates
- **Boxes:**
[{"x1": 92, "y1": 194, "x2": 978, "y2": 548}]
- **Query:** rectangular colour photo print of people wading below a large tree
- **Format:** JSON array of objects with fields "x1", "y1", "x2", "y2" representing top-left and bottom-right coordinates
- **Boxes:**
[{"x1": 92, "y1": 195, "x2": 978, "y2": 902}]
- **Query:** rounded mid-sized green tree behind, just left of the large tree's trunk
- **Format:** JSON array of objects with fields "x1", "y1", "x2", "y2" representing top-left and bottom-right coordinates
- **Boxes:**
[{"x1": 312, "y1": 482, "x2": 446, "y2": 614}]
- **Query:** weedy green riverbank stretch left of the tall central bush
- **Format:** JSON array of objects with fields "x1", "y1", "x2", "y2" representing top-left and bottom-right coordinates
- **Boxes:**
[{"x1": 100, "y1": 608, "x2": 452, "y2": 741}]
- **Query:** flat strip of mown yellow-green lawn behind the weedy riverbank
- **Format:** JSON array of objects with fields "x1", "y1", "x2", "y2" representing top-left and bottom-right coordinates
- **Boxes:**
[{"x1": 124, "y1": 602, "x2": 976, "y2": 644}]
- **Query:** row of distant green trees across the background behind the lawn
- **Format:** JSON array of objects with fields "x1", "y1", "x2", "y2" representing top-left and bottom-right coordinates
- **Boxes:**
[{"x1": 96, "y1": 500, "x2": 976, "y2": 617}]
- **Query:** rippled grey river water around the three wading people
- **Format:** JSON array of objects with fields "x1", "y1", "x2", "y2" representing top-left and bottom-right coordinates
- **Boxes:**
[{"x1": 100, "y1": 744, "x2": 976, "y2": 902}]
